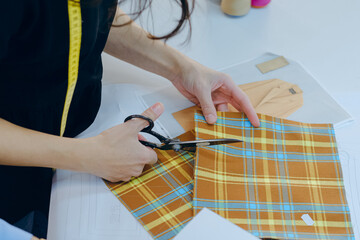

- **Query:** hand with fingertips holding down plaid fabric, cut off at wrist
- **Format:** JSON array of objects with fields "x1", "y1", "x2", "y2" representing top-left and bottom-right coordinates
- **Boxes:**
[{"x1": 171, "y1": 58, "x2": 260, "y2": 127}]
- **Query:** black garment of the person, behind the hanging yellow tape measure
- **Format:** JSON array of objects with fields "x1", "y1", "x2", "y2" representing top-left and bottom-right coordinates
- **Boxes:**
[{"x1": 0, "y1": 0, "x2": 117, "y2": 237}]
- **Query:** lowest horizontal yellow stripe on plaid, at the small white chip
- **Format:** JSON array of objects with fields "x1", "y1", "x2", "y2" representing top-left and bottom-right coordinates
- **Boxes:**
[{"x1": 228, "y1": 218, "x2": 351, "y2": 228}]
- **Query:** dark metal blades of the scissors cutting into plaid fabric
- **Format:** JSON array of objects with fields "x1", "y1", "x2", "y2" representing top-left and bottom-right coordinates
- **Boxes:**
[{"x1": 162, "y1": 138, "x2": 243, "y2": 151}]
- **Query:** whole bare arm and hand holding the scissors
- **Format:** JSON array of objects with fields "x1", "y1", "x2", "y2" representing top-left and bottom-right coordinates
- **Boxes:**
[{"x1": 0, "y1": 103, "x2": 164, "y2": 182}]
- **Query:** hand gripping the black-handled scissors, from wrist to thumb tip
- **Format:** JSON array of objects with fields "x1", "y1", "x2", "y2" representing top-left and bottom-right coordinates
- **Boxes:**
[{"x1": 82, "y1": 103, "x2": 164, "y2": 182}]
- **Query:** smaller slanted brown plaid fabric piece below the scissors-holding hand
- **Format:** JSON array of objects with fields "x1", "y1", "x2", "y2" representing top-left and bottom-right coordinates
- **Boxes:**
[{"x1": 105, "y1": 132, "x2": 194, "y2": 239}]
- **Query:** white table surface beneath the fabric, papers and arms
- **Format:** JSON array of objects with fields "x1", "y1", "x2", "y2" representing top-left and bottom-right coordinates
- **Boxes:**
[{"x1": 48, "y1": 0, "x2": 360, "y2": 240}]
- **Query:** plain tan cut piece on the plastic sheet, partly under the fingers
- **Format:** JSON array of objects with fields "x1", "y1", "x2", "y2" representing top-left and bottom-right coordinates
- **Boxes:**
[{"x1": 173, "y1": 79, "x2": 303, "y2": 131}]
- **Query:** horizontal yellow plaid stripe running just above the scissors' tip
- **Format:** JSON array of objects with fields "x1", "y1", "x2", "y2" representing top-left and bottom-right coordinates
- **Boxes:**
[{"x1": 198, "y1": 128, "x2": 332, "y2": 148}]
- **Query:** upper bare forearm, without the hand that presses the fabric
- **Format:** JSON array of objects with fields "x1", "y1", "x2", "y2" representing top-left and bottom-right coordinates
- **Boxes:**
[{"x1": 105, "y1": 8, "x2": 193, "y2": 80}]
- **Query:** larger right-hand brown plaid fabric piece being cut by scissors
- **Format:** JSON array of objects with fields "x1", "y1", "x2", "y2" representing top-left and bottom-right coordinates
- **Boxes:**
[{"x1": 193, "y1": 112, "x2": 354, "y2": 239}]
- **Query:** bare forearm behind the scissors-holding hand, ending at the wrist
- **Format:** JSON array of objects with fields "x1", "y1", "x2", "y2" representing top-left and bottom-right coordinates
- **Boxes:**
[{"x1": 0, "y1": 118, "x2": 82, "y2": 170}]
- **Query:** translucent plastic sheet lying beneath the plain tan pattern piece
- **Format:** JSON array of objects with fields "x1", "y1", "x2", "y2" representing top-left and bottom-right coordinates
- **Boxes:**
[{"x1": 142, "y1": 53, "x2": 353, "y2": 137}]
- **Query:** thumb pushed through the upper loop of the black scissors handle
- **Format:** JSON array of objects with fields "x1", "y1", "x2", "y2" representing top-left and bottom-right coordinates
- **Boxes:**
[{"x1": 129, "y1": 103, "x2": 164, "y2": 132}]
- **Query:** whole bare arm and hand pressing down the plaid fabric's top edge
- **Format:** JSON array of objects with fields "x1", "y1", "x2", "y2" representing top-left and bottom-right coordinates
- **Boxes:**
[{"x1": 105, "y1": 9, "x2": 259, "y2": 126}]
